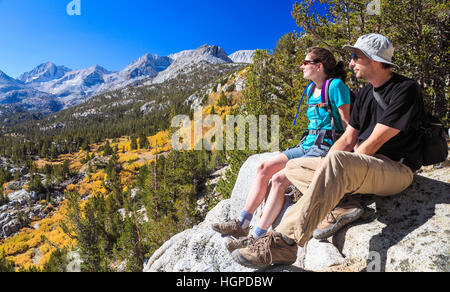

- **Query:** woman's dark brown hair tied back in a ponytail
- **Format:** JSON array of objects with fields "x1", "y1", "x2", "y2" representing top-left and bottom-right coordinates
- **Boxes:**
[{"x1": 307, "y1": 47, "x2": 347, "y2": 82}]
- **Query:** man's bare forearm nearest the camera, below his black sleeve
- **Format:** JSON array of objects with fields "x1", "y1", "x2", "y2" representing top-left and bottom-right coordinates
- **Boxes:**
[{"x1": 355, "y1": 124, "x2": 400, "y2": 156}]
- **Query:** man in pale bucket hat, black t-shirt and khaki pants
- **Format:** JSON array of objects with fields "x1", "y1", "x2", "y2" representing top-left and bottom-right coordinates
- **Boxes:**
[{"x1": 232, "y1": 34, "x2": 423, "y2": 268}]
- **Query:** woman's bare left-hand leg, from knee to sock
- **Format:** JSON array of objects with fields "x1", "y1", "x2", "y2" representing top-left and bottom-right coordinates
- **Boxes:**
[{"x1": 244, "y1": 153, "x2": 289, "y2": 214}]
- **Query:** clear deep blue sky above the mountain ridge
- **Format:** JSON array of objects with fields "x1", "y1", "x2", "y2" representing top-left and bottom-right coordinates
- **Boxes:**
[{"x1": 0, "y1": 0, "x2": 298, "y2": 77}]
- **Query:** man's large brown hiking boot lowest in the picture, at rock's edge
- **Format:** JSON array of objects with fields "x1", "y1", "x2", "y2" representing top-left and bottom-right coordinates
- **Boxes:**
[{"x1": 231, "y1": 231, "x2": 298, "y2": 269}]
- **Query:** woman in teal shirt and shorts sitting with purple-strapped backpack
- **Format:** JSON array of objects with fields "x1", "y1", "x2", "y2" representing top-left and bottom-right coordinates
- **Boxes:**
[{"x1": 212, "y1": 47, "x2": 350, "y2": 252}]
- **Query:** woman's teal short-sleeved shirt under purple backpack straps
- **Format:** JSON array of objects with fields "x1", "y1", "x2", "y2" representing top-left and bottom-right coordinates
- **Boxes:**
[{"x1": 302, "y1": 79, "x2": 351, "y2": 150}]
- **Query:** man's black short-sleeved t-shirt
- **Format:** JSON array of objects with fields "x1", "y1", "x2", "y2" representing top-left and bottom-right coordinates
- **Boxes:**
[{"x1": 350, "y1": 73, "x2": 424, "y2": 171}]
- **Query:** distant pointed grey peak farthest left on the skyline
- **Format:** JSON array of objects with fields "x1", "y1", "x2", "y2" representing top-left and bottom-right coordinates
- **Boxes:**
[{"x1": 17, "y1": 62, "x2": 72, "y2": 83}]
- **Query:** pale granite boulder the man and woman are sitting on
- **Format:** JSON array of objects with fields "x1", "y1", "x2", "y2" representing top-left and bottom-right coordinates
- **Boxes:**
[{"x1": 144, "y1": 153, "x2": 450, "y2": 272}]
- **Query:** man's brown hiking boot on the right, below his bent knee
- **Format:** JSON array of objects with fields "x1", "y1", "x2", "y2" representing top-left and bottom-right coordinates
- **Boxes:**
[{"x1": 313, "y1": 200, "x2": 364, "y2": 240}]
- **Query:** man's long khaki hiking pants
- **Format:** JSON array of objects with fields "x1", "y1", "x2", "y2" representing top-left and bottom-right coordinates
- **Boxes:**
[{"x1": 276, "y1": 151, "x2": 414, "y2": 247}]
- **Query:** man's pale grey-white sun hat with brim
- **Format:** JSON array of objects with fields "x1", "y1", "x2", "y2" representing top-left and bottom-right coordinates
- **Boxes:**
[{"x1": 344, "y1": 33, "x2": 399, "y2": 68}]
